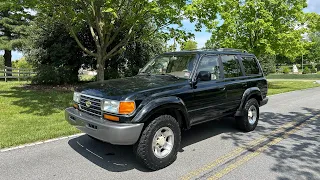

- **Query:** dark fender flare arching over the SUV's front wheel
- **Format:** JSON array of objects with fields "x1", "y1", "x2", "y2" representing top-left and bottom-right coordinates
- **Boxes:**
[{"x1": 132, "y1": 96, "x2": 190, "y2": 129}]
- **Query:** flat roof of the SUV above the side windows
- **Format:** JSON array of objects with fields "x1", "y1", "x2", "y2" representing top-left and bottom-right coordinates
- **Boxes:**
[{"x1": 164, "y1": 49, "x2": 254, "y2": 56}]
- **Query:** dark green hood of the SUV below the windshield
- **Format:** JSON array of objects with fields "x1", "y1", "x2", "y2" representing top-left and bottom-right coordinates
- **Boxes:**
[{"x1": 76, "y1": 75, "x2": 187, "y2": 100}]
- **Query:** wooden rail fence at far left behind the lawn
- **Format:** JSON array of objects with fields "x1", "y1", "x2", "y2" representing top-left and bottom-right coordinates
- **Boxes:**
[{"x1": 0, "y1": 66, "x2": 36, "y2": 82}]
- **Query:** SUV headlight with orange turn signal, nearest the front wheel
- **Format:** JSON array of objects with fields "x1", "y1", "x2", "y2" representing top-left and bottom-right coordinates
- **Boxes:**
[{"x1": 101, "y1": 100, "x2": 136, "y2": 114}]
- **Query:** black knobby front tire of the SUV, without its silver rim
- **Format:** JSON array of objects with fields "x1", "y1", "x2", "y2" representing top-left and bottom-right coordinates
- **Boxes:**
[{"x1": 134, "y1": 115, "x2": 181, "y2": 170}]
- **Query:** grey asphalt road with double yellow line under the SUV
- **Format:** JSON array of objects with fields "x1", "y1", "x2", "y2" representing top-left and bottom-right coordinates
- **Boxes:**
[{"x1": 0, "y1": 88, "x2": 320, "y2": 180}]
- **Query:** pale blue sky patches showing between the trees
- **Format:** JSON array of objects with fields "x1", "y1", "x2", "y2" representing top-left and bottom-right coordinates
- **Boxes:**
[{"x1": 0, "y1": 0, "x2": 320, "y2": 60}]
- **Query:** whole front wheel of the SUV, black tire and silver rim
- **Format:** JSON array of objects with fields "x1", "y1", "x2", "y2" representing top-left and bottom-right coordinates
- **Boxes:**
[{"x1": 134, "y1": 115, "x2": 181, "y2": 170}]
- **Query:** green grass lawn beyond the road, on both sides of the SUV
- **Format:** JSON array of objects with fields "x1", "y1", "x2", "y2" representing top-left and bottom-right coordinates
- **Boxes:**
[{"x1": 0, "y1": 81, "x2": 320, "y2": 149}]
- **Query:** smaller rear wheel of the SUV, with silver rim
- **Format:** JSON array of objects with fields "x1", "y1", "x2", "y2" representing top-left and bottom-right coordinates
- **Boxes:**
[{"x1": 236, "y1": 98, "x2": 259, "y2": 132}]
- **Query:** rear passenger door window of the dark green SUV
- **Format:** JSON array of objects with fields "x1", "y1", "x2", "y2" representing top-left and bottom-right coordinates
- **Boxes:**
[{"x1": 221, "y1": 55, "x2": 242, "y2": 78}]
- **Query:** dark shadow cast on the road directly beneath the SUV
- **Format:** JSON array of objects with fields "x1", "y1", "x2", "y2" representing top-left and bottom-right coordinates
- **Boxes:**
[{"x1": 68, "y1": 118, "x2": 238, "y2": 172}]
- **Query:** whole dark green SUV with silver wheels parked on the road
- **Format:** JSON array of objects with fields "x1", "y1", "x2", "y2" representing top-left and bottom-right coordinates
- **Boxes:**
[{"x1": 65, "y1": 49, "x2": 268, "y2": 170}]
